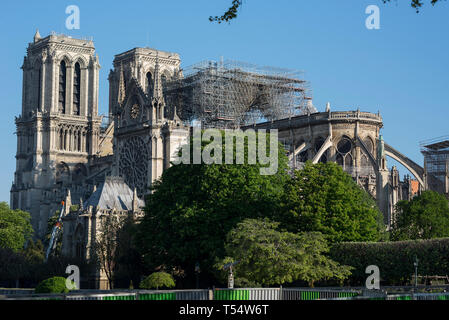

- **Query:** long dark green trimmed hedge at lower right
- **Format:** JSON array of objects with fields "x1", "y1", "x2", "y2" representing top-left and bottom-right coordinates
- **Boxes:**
[{"x1": 329, "y1": 238, "x2": 449, "y2": 286}]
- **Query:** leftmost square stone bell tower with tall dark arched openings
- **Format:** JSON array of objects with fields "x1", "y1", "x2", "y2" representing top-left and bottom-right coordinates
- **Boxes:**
[{"x1": 11, "y1": 31, "x2": 101, "y2": 237}]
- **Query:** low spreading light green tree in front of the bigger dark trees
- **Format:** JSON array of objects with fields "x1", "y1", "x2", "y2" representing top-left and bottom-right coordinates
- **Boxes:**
[{"x1": 216, "y1": 219, "x2": 351, "y2": 287}]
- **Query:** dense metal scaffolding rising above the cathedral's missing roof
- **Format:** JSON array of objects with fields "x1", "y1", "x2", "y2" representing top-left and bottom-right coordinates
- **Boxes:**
[{"x1": 164, "y1": 60, "x2": 317, "y2": 128}]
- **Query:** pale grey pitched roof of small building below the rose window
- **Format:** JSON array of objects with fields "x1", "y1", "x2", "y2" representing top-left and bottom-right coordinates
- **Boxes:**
[{"x1": 84, "y1": 177, "x2": 145, "y2": 210}]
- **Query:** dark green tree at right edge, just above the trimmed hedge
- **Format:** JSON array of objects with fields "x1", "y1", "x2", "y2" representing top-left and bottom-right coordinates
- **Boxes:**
[{"x1": 391, "y1": 190, "x2": 449, "y2": 241}]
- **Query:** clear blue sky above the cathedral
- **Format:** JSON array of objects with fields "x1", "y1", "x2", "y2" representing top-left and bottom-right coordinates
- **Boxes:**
[{"x1": 0, "y1": 0, "x2": 449, "y2": 202}]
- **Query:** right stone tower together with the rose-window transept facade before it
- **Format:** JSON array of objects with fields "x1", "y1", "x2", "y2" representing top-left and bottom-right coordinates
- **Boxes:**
[{"x1": 109, "y1": 48, "x2": 189, "y2": 197}]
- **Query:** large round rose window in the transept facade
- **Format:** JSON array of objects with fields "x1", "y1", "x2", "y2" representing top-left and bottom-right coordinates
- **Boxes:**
[{"x1": 119, "y1": 137, "x2": 148, "y2": 196}]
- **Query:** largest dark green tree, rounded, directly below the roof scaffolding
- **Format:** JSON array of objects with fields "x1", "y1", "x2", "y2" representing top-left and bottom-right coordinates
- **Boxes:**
[{"x1": 138, "y1": 131, "x2": 289, "y2": 275}]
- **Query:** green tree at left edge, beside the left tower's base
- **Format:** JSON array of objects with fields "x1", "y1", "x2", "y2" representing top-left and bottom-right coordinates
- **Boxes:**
[{"x1": 0, "y1": 202, "x2": 33, "y2": 252}]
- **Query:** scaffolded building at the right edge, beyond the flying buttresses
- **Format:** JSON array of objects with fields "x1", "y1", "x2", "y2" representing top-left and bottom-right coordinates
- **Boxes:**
[{"x1": 420, "y1": 136, "x2": 449, "y2": 195}]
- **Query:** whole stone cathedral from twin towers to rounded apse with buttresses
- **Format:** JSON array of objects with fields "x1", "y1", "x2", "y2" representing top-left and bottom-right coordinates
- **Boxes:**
[{"x1": 11, "y1": 32, "x2": 425, "y2": 245}]
